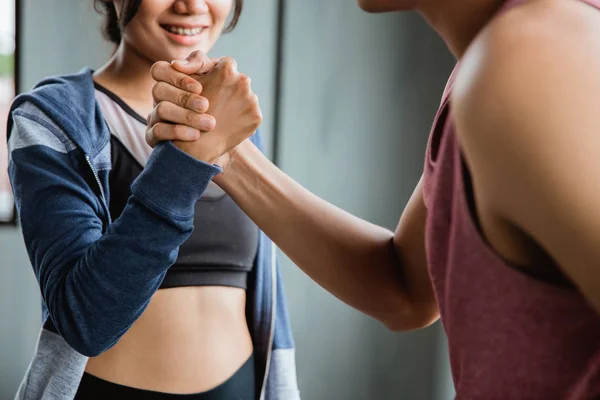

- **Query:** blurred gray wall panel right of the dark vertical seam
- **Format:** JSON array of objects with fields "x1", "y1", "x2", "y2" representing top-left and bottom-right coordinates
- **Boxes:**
[{"x1": 279, "y1": 0, "x2": 453, "y2": 400}]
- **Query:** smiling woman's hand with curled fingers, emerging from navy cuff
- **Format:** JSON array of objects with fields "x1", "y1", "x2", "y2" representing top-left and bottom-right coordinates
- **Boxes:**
[{"x1": 146, "y1": 51, "x2": 217, "y2": 147}]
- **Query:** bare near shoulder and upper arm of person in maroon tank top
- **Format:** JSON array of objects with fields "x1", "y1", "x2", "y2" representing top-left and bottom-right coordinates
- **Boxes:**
[{"x1": 453, "y1": 2, "x2": 600, "y2": 310}]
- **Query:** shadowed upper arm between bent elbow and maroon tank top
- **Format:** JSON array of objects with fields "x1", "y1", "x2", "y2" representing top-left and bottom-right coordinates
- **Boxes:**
[{"x1": 394, "y1": 177, "x2": 439, "y2": 326}]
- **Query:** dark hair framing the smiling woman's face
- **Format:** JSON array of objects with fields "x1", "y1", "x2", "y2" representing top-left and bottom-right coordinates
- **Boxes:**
[{"x1": 94, "y1": 0, "x2": 244, "y2": 45}]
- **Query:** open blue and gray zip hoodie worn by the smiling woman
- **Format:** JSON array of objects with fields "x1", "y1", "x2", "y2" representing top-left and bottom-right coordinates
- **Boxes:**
[{"x1": 8, "y1": 69, "x2": 300, "y2": 400}]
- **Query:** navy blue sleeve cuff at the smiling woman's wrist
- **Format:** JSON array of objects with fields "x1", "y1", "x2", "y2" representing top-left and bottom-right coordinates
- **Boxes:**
[{"x1": 131, "y1": 142, "x2": 223, "y2": 218}]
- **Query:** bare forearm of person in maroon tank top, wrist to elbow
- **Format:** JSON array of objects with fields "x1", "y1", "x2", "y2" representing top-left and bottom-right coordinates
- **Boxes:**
[{"x1": 214, "y1": 142, "x2": 418, "y2": 325}]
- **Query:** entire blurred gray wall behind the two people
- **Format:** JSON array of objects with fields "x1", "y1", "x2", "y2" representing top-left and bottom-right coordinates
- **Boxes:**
[{"x1": 0, "y1": 0, "x2": 453, "y2": 400}]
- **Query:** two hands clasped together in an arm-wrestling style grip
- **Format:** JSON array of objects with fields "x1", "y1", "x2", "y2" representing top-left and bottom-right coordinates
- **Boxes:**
[{"x1": 146, "y1": 51, "x2": 262, "y2": 166}]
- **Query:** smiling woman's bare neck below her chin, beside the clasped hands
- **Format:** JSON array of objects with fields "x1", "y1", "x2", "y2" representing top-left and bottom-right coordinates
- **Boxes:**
[{"x1": 94, "y1": 42, "x2": 155, "y2": 109}]
